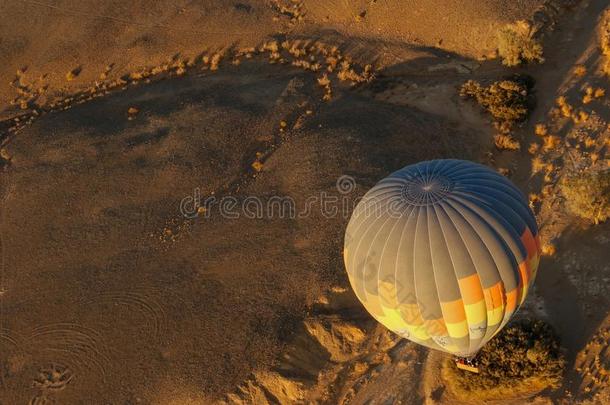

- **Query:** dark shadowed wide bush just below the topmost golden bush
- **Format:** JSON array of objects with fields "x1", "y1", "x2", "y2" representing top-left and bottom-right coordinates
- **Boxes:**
[{"x1": 460, "y1": 76, "x2": 530, "y2": 123}]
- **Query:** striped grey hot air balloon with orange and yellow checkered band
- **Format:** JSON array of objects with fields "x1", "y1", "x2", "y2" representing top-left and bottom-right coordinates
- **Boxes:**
[{"x1": 344, "y1": 159, "x2": 540, "y2": 358}]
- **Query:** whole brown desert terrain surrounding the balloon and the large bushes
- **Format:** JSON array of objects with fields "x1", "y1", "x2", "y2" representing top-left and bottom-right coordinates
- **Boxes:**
[{"x1": 0, "y1": 0, "x2": 610, "y2": 405}]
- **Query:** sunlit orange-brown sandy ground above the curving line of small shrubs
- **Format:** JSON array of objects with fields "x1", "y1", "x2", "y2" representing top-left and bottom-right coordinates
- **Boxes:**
[{"x1": 0, "y1": 0, "x2": 548, "y2": 118}]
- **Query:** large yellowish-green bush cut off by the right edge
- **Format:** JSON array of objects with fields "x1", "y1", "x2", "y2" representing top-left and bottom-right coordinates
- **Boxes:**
[{"x1": 559, "y1": 170, "x2": 610, "y2": 224}]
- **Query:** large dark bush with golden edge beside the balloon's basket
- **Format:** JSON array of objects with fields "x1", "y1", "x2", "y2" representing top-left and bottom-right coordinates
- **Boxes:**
[{"x1": 443, "y1": 320, "x2": 565, "y2": 399}]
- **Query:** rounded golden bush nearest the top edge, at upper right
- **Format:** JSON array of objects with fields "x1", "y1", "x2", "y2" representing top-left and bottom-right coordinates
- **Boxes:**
[{"x1": 498, "y1": 21, "x2": 544, "y2": 66}]
